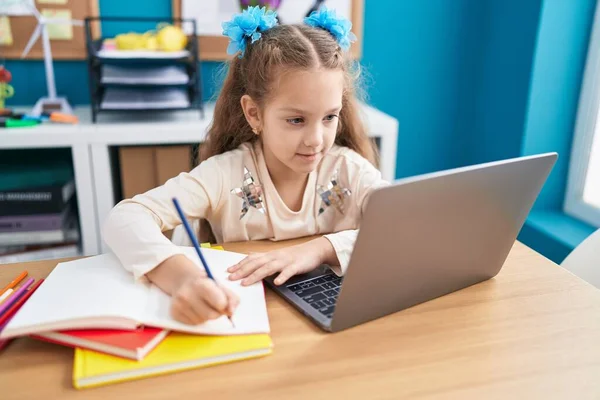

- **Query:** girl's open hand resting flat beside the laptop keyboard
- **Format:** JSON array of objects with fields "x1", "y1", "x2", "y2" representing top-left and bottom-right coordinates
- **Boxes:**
[{"x1": 227, "y1": 238, "x2": 337, "y2": 286}]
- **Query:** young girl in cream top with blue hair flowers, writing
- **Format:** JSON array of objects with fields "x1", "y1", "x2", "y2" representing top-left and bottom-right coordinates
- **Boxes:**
[{"x1": 103, "y1": 7, "x2": 386, "y2": 324}]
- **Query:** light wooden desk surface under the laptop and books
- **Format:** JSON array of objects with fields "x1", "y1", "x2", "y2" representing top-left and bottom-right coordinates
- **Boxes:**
[{"x1": 0, "y1": 239, "x2": 600, "y2": 400}]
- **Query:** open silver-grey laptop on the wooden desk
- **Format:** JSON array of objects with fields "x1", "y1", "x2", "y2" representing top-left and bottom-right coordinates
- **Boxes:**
[{"x1": 265, "y1": 153, "x2": 557, "y2": 332}]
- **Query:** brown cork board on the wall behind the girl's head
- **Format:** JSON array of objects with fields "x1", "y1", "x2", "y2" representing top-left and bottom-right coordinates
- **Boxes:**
[{"x1": 172, "y1": 0, "x2": 364, "y2": 61}]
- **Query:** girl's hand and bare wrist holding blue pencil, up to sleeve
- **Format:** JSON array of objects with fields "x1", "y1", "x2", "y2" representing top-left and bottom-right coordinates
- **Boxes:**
[{"x1": 147, "y1": 255, "x2": 239, "y2": 325}]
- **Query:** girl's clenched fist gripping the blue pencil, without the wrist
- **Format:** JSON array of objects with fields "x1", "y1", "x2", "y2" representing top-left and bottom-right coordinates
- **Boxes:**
[{"x1": 171, "y1": 275, "x2": 240, "y2": 325}]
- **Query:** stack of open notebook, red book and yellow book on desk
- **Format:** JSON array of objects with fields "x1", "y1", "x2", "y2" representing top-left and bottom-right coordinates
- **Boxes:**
[{"x1": 0, "y1": 246, "x2": 273, "y2": 389}]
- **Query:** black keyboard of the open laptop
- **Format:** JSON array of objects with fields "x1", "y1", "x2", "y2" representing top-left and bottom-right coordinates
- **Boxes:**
[{"x1": 287, "y1": 273, "x2": 343, "y2": 318}]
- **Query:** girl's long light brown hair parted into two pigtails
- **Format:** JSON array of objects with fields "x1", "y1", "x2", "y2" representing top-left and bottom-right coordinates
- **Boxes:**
[{"x1": 200, "y1": 25, "x2": 377, "y2": 165}]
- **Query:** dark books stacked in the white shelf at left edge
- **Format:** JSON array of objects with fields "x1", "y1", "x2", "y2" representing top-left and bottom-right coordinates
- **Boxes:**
[{"x1": 0, "y1": 165, "x2": 79, "y2": 264}]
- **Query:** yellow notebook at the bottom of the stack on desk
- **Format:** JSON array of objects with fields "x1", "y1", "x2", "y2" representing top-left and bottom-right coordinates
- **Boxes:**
[{"x1": 73, "y1": 332, "x2": 273, "y2": 389}]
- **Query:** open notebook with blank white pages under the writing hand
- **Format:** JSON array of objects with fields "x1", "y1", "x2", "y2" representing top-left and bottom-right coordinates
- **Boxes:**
[{"x1": 0, "y1": 247, "x2": 270, "y2": 338}]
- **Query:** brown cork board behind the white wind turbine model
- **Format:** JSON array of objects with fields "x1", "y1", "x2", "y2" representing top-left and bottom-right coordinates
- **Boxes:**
[{"x1": 0, "y1": 0, "x2": 99, "y2": 60}]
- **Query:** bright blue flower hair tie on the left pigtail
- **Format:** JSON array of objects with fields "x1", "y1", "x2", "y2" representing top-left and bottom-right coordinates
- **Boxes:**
[{"x1": 221, "y1": 6, "x2": 277, "y2": 58}]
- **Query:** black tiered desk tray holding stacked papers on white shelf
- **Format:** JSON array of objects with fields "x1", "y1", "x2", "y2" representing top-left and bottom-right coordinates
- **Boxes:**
[{"x1": 86, "y1": 17, "x2": 204, "y2": 123}]
